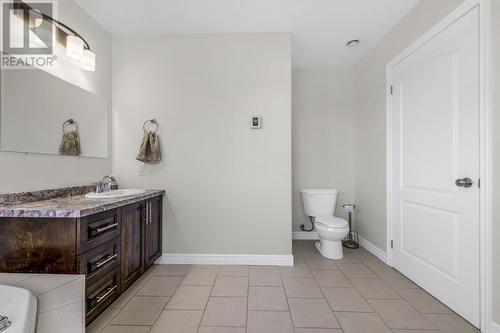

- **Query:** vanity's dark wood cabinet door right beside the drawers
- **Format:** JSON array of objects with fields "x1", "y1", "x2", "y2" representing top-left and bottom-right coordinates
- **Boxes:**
[{"x1": 121, "y1": 202, "x2": 144, "y2": 289}]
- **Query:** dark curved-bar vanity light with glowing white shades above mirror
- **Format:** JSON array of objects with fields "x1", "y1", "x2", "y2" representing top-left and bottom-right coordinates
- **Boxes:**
[{"x1": 14, "y1": 1, "x2": 96, "y2": 72}]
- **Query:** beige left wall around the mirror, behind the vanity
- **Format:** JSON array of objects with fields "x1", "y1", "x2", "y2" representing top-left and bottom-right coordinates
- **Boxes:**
[{"x1": 0, "y1": 0, "x2": 111, "y2": 193}]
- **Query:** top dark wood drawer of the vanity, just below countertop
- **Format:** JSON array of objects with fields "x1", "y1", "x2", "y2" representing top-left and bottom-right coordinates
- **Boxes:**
[{"x1": 79, "y1": 209, "x2": 121, "y2": 253}]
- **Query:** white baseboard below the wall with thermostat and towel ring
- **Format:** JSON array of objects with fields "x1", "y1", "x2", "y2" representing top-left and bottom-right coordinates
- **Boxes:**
[{"x1": 156, "y1": 253, "x2": 293, "y2": 266}]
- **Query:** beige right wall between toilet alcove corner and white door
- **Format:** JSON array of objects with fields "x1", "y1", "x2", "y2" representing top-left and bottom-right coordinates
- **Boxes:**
[{"x1": 354, "y1": 0, "x2": 463, "y2": 251}]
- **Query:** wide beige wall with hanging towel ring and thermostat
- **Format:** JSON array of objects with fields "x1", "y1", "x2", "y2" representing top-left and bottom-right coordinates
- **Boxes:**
[{"x1": 113, "y1": 33, "x2": 292, "y2": 255}]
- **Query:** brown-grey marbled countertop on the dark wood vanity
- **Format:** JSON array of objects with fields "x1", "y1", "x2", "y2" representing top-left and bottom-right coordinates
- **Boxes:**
[{"x1": 0, "y1": 190, "x2": 165, "y2": 218}]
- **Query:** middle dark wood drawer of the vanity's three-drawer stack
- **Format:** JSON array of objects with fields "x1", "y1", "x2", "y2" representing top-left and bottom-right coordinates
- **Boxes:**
[{"x1": 79, "y1": 237, "x2": 121, "y2": 284}]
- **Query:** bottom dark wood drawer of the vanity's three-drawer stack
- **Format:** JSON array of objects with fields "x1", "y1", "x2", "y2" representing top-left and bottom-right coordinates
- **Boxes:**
[{"x1": 85, "y1": 268, "x2": 120, "y2": 325}]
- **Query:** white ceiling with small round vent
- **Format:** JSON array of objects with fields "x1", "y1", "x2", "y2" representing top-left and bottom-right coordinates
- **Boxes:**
[{"x1": 76, "y1": 0, "x2": 419, "y2": 68}]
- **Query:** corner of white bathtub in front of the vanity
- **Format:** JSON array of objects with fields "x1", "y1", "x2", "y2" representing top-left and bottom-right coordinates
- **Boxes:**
[{"x1": 0, "y1": 285, "x2": 37, "y2": 333}]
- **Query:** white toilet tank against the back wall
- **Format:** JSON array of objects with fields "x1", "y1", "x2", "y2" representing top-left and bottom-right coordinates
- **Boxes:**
[{"x1": 300, "y1": 188, "x2": 338, "y2": 216}]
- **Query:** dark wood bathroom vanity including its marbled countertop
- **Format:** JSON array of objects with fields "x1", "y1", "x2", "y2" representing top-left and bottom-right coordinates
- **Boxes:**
[{"x1": 0, "y1": 191, "x2": 164, "y2": 324}]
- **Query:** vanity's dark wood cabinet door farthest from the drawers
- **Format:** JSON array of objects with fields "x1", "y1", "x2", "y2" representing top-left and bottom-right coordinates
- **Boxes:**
[{"x1": 144, "y1": 196, "x2": 163, "y2": 268}]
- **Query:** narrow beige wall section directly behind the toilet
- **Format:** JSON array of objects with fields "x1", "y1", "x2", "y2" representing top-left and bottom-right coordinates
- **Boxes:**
[{"x1": 292, "y1": 68, "x2": 354, "y2": 231}]
